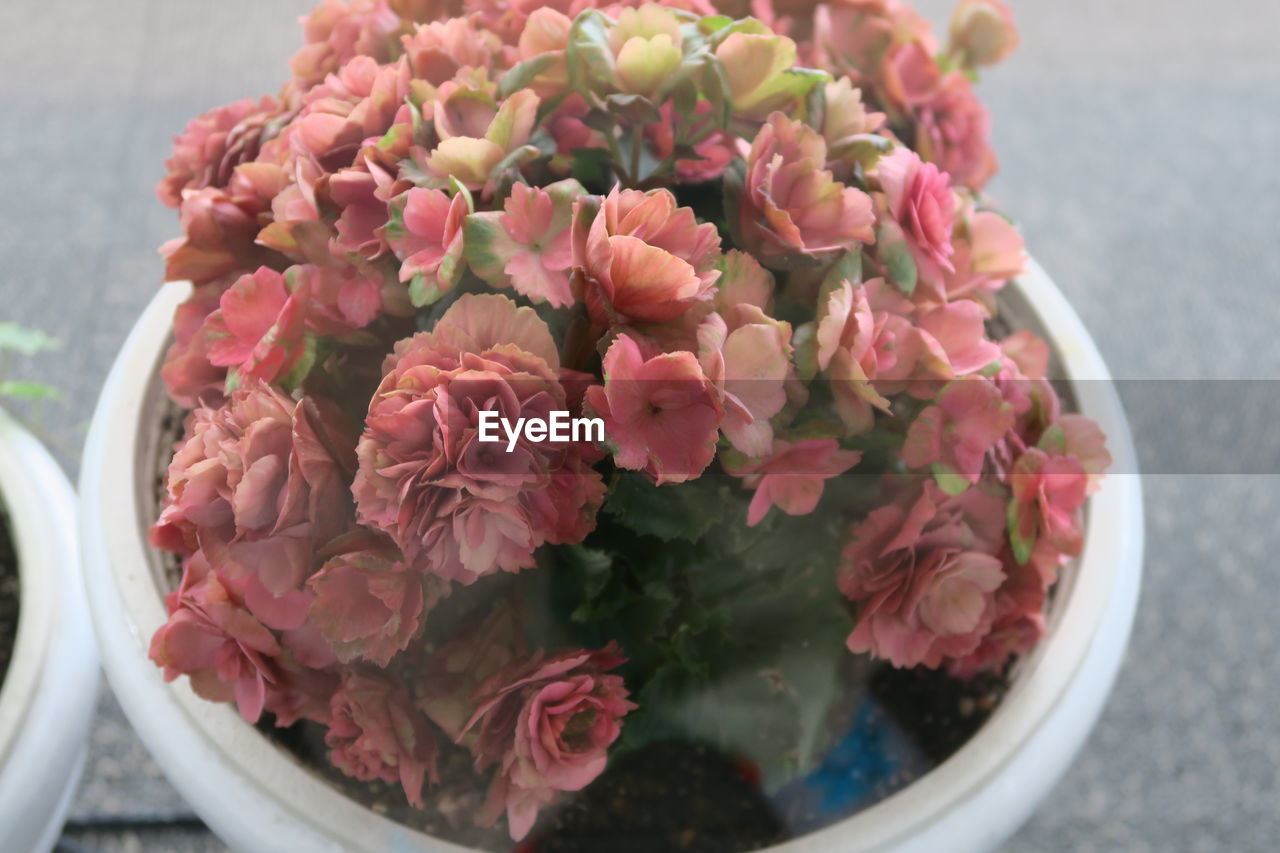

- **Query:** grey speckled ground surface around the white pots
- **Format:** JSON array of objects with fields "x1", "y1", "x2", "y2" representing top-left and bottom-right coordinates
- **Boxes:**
[{"x1": 0, "y1": 0, "x2": 1280, "y2": 853}]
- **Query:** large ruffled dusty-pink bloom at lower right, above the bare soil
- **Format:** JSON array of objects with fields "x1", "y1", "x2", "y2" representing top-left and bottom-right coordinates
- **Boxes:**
[{"x1": 840, "y1": 480, "x2": 1005, "y2": 669}]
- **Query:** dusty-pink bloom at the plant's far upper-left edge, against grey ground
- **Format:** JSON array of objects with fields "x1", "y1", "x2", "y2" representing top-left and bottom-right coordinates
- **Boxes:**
[{"x1": 156, "y1": 97, "x2": 288, "y2": 207}]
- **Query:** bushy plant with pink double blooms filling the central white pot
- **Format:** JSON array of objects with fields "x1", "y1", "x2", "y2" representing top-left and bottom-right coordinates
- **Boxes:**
[{"x1": 151, "y1": 0, "x2": 1108, "y2": 839}]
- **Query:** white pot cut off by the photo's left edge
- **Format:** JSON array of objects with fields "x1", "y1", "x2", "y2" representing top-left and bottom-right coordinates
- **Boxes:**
[{"x1": 0, "y1": 410, "x2": 99, "y2": 853}]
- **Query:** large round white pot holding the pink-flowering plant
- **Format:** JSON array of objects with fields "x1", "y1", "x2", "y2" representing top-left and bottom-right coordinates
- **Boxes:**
[{"x1": 81, "y1": 265, "x2": 1143, "y2": 853}]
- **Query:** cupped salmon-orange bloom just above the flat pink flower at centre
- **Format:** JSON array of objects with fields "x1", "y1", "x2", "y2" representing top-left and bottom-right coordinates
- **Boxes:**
[{"x1": 573, "y1": 188, "x2": 719, "y2": 325}]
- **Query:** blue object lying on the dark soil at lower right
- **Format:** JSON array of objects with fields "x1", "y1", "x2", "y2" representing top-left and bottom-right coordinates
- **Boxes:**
[{"x1": 773, "y1": 699, "x2": 932, "y2": 835}]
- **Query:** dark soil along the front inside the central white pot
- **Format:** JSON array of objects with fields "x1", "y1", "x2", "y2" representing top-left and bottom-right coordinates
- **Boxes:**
[{"x1": 260, "y1": 665, "x2": 1007, "y2": 853}]
